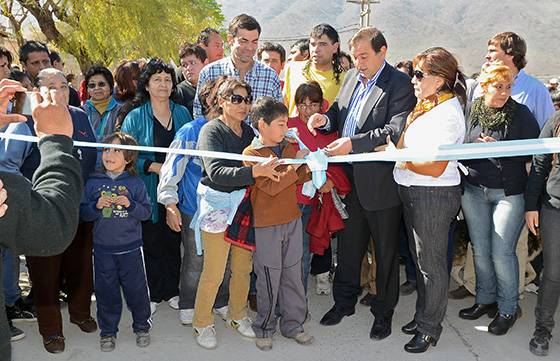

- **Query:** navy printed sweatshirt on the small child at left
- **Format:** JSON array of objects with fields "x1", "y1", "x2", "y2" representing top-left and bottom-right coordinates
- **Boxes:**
[{"x1": 80, "y1": 172, "x2": 152, "y2": 254}]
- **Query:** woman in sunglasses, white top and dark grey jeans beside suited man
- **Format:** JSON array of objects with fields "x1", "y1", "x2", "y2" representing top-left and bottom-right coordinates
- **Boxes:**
[{"x1": 378, "y1": 47, "x2": 466, "y2": 353}]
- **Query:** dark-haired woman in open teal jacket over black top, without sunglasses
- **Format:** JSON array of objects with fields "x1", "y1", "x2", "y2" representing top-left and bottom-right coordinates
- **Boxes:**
[{"x1": 121, "y1": 59, "x2": 192, "y2": 313}]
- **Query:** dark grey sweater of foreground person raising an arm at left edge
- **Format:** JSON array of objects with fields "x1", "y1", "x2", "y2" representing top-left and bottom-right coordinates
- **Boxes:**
[{"x1": 0, "y1": 135, "x2": 83, "y2": 361}]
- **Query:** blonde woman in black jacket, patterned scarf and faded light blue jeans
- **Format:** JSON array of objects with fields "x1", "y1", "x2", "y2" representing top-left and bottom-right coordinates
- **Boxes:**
[{"x1": 459, "y1": 62, "x2": 539, "y2": 335}]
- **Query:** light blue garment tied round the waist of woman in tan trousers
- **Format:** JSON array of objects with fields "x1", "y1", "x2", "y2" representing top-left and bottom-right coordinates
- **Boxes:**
[{"x1": 190, "y1": 183, "x2": 246, "y2": 256}]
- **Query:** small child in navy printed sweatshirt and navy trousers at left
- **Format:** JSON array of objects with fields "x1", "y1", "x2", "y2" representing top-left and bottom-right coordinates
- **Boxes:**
[{"x1": 80, "y1": 133, "x2": 151, "y2": 351}]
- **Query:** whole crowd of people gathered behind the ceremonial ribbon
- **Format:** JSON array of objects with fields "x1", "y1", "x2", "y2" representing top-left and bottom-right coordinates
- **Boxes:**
[{"x1": 0, "y1": 14, "x2": 560, "y2": 355}]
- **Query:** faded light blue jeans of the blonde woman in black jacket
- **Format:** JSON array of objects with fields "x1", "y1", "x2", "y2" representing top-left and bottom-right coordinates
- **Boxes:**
[{"x1": 461, "y1": 183, "x2": 525, "y2": 315}]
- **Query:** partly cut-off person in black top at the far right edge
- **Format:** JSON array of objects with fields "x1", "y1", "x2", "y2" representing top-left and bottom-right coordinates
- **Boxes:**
[{"x1": 525, "y1": 111, "x2": 560, "y2": 356}]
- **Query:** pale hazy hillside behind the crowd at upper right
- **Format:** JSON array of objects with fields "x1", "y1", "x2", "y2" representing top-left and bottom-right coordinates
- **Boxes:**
[{"x1": 218, "y1": 0, "x2": 560, "y2": 77}]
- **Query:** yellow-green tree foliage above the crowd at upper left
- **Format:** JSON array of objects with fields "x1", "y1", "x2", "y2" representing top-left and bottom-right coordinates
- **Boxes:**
[{"x1": 3, "y1": 0, "x2": 224, "y2": 70}]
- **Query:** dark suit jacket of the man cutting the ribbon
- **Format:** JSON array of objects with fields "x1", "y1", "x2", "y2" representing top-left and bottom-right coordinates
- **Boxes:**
[{"x1": 325, "y1": 64, "x2": 416, "y2": 211}]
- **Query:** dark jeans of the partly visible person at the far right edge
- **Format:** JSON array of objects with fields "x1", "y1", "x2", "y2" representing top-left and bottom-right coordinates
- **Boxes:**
[{"x1": 535, "y1": 206, "x2": 560, "y2": 332}]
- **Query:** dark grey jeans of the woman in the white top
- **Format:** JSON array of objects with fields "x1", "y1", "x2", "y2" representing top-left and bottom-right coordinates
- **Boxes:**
[{"x1": 399, "y1": 186, "x2": 461, "y2": 339}]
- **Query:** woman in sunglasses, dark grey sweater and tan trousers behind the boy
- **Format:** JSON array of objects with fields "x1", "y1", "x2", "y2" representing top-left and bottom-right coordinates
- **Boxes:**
[{"x1": 191, "y1": 78, "x2": 278, "y2": 349}]
